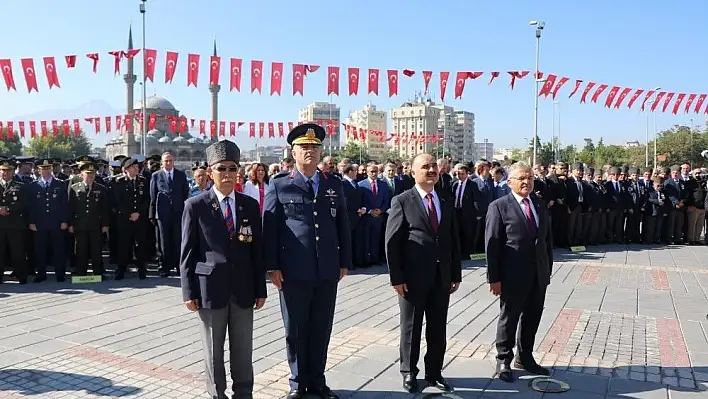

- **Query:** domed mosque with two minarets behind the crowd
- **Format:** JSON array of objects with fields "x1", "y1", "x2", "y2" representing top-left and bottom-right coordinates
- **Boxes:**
[{"x1": 106, "y1": 30, "x2": 221, "y2": 167}]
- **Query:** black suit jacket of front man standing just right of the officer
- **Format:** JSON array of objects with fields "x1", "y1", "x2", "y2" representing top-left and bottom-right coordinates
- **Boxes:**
[{"x1": 385, "y1": 188, "x2": 462, "y2": 303}]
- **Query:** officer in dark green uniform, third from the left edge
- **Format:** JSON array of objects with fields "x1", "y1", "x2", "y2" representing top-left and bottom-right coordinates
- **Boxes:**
[{"x1": 69, "y1": 160, "x2": 110, "y2": 276}]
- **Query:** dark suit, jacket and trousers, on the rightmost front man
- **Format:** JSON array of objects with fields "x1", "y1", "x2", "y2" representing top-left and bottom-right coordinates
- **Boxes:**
[{"x1": 485, "y1": 193, "x2": 553, "y2": 364}]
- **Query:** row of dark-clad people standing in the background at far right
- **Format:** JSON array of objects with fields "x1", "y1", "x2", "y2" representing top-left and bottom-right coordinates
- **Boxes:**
[{"x1": 534, "y1": 162, "x2": 706, "y2": 247}]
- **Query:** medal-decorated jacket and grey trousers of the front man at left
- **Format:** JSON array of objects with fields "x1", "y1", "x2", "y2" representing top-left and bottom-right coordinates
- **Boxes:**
[{"x1": 180, "y1": 189, "x2": 267, "y2": 398}]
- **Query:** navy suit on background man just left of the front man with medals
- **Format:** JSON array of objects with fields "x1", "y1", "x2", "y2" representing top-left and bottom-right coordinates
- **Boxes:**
[{"x1": 150, "y1": 168, "x2": 189, "y2": 274}]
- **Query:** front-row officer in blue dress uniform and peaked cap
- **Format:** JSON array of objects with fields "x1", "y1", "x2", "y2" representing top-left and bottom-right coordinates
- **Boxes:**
[{"x1": 263, "y1": 123, "x2": 352, "y2": 399}]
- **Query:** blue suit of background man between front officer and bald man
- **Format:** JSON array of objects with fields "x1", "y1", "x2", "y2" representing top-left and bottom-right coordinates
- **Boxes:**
[{"x1": 359, "y1": 179, "x2": 391, "y2": 264}]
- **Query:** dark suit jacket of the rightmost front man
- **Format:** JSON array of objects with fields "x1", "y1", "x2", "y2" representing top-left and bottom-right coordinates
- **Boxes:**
[{"x1": 484, "y1": 194, "x2": 553, "y2": 305}]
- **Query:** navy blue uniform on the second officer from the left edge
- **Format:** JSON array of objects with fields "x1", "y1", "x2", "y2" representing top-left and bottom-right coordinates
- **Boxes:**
[{"x1": 28, "y1": 178, "x2": 69, "y2": 281}]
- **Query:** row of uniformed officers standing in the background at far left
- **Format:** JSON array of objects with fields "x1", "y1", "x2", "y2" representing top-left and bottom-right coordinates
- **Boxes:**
[{"x1": 0, "y1": 156, "x2": 159, "y2": 284}]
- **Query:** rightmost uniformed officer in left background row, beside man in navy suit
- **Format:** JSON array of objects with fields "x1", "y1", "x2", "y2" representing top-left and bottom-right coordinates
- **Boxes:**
[{"x1": 113, "y1": 158, "x2": 150, "y2": 280}]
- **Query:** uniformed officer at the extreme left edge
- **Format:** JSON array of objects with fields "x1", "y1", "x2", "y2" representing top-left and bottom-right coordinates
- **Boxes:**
[{"x1": 0, "y1": 159, "x2": 27, "y2": 284}]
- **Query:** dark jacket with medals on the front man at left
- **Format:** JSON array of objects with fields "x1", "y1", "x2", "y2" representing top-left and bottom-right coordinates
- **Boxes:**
[{"x1": 180, "y1": 190, "x2": 267, "y2": 309}]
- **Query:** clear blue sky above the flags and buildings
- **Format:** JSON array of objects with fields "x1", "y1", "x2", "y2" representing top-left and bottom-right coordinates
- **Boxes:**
[{"x1": 0, "y1": 0, "x2": 708, "y2": 147}]
